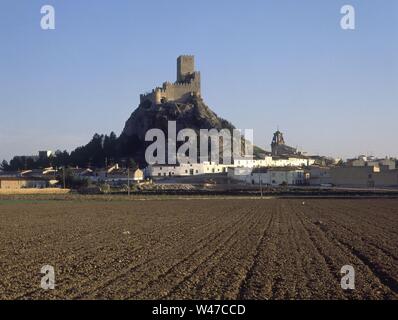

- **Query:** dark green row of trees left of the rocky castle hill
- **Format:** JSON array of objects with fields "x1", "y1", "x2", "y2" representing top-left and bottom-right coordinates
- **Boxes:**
[{"x1": 0, "y1": 132, "x2": 139, "y2": 171}]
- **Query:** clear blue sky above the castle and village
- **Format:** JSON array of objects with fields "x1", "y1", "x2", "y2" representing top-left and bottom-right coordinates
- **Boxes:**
[{"x1": 0, "y1": 0, "x2": 398, "y2": 160}]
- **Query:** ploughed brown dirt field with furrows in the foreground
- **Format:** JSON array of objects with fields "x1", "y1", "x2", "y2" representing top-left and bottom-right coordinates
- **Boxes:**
[{"x1": 0, "y1": 199, "x2": 398, "y2": 299}]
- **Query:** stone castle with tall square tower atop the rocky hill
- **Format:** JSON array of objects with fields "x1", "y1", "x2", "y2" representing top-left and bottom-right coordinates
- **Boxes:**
[{"x1": 140, "y1": 55, "x2": 201, "y2": 104}]
